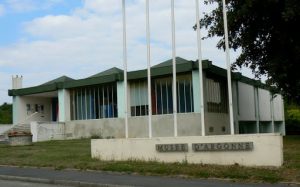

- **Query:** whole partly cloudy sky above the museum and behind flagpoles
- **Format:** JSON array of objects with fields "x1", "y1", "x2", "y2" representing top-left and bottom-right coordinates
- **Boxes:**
[{"x1": 0, "y1": 0, "x2": 248, "y2": 104}]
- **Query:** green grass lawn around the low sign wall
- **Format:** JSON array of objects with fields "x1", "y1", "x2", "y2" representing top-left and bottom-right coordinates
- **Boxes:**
[{"x1": 0, "y1": 136, "x2": 300, "y2": 183}]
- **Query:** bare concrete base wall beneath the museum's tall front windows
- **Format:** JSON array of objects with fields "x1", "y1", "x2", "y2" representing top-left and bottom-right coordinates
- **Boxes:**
[{"x1": 65, "y1": 113, "x2": 201, "y2": 139}]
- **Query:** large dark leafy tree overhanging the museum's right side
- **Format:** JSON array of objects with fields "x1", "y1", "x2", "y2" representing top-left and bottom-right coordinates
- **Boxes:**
[{"x1": 194, "y1": 0, "x2": 300, "y2": 104}]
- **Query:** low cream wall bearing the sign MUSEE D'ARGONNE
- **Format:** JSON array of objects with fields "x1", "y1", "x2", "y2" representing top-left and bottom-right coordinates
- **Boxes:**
[{"x1": 91, "y1": 134, "x2": 283, "y2": 166}]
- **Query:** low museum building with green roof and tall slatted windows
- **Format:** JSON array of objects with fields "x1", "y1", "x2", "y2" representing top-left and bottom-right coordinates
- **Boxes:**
[{"x1": 9, "y1": 57, "x2": 285, "y2": 138}]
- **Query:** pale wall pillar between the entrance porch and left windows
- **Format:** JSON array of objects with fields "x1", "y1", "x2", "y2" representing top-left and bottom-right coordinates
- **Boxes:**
[{"x1": 58, "y1": 89, "x2": 71, "y2": 122}]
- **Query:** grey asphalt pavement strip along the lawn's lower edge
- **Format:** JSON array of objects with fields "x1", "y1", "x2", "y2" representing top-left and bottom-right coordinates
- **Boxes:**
[{"x1": 0, "y1": 166, "x2": 296, "y2": 187}]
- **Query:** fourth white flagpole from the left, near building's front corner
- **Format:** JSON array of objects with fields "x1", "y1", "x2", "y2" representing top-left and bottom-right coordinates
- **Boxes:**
[{"x1": 195, "y1": 0, "x2": 205, "y2": 136}]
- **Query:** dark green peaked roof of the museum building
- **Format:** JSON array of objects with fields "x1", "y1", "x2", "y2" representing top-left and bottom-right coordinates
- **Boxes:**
[{"x1": 8, "y1": 57, "x2": 266, "y2": 96}]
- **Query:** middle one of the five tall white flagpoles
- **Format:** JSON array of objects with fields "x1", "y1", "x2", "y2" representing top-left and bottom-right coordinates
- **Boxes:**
[{"x1": 171, "y1": 0, "x2": 177, "y2": 137}]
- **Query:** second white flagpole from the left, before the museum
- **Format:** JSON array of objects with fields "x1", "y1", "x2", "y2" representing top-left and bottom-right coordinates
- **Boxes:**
[{"x1": 146, "y1": 0, "x2": 152, "y2": 138}]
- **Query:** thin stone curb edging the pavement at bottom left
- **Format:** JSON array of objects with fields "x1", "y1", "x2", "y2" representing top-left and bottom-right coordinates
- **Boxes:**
[{"x1": 0, "y1": 175, "x2": 132, "y2": 187}]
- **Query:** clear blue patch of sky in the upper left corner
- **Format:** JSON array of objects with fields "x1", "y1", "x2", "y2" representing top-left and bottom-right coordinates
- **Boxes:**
[{"x1": 0, "y1": 0, "x2": 83, "y2": 47}]
